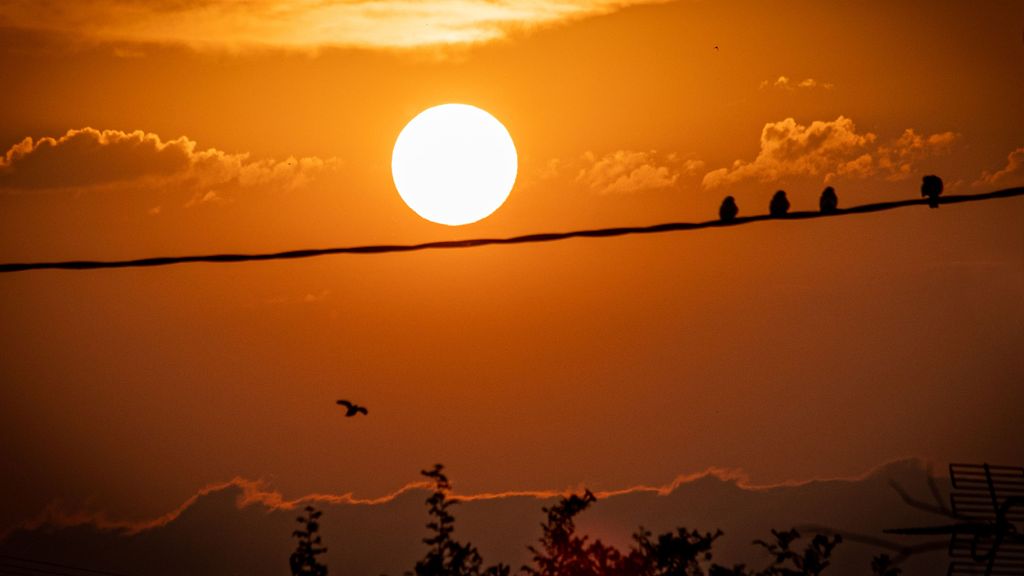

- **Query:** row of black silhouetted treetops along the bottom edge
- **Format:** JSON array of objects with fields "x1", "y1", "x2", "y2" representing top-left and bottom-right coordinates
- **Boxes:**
[{"x1": 289, "y1": 464, "x2": 901, "y2": 576}]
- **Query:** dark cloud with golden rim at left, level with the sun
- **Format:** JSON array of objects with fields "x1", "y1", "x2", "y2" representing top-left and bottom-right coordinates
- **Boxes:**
[{"x1": 0, "y1": 128, "x2": 337, "y2": 195}]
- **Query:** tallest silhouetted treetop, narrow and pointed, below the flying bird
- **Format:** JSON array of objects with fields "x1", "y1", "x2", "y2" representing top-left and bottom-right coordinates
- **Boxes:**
[{"x1": 415, "y1": 464, "x2": 509, "y2": 576}]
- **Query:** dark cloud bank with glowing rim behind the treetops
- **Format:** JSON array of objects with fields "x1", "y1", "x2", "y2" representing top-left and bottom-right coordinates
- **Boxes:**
[{"x1": 0, "y1": 460, "x2": 948, "y2": 576}]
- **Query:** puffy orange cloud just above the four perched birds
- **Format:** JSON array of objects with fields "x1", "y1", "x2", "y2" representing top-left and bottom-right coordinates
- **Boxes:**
[{"x1": 702, "y1": 116, "x2": 957, "y2": 189}]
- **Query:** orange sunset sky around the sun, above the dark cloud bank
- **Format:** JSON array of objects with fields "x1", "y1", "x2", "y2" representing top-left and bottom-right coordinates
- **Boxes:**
[{"x1": 0, "y1": 0, "x2": 1024, "y2": 565}]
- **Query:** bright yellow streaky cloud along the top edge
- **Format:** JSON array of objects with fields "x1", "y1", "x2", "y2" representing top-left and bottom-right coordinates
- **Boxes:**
[{"x1": 0, "y1": 0, "x2": 655, "y2": 49}]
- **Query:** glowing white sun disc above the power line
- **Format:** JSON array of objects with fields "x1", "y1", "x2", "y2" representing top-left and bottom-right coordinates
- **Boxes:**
[{"x1": 391, "y1": 104, "x2": 518, "y2": 225}]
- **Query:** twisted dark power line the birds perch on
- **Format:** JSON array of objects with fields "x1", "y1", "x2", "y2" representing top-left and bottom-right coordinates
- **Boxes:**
[{"x1": 0, "y1": 188, "x2": 1024, "y2": 273}]
